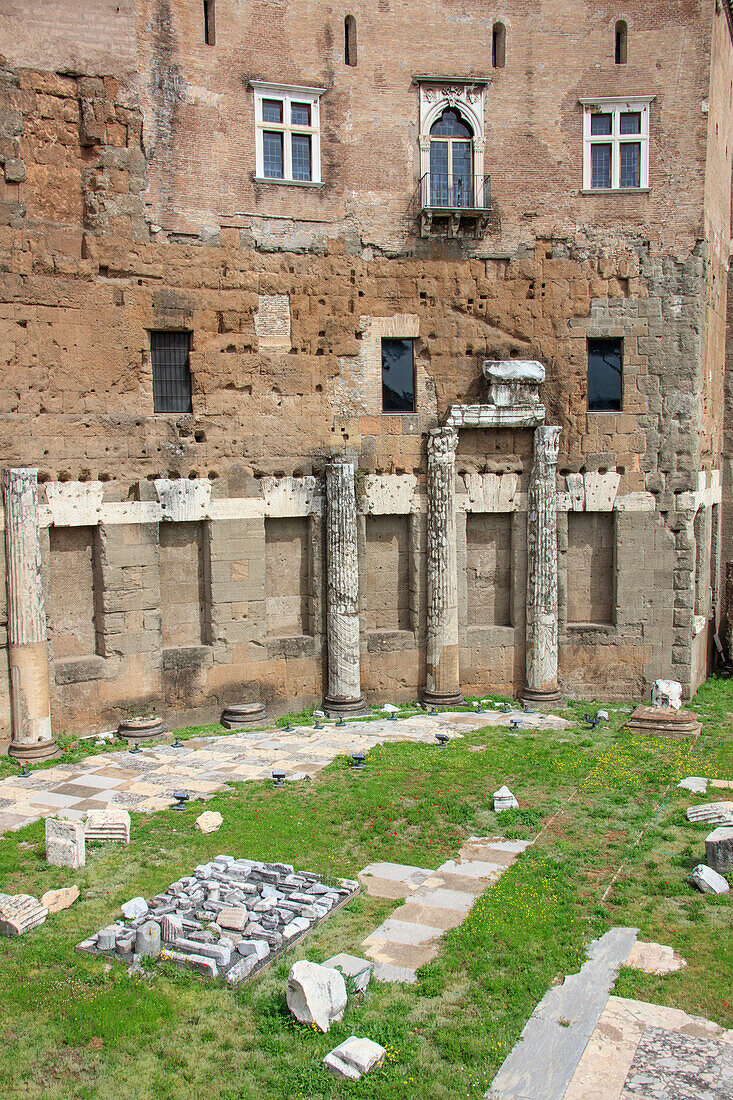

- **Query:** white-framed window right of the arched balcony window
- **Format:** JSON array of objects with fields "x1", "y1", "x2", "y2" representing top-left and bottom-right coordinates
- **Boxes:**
[{"x1": 581, "y1": 96, "x2": 654, "y2": 190}]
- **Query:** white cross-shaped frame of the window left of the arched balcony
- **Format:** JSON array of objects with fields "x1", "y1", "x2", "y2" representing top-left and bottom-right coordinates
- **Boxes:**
[{"x1": 250, "y1": 80, "x2": 326, "y2": 187}]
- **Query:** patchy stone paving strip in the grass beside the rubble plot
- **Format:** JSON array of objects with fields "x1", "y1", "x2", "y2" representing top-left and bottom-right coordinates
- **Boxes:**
[{"x1": 358, "y1": 836, "x2": 530, "y2": 982}]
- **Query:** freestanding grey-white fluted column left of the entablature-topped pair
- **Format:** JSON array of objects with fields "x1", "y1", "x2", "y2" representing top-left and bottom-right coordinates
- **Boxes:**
[{"x1": 324, "y1": 459, "x2": 368, "y2": 715}]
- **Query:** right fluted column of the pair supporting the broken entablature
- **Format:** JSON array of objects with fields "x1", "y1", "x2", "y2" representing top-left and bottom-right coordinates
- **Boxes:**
[{"x1": 523, "y1": 427, "x2": 560, "y2": 706}]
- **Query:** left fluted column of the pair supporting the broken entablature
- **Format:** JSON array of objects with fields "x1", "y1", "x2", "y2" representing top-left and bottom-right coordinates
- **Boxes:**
[{"x1": 423, "y1": 428, "x2": 463, "y2": 706}]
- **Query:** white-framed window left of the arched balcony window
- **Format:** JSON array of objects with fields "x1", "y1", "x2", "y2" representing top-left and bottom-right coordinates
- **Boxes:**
[{"x1": 252, "y1": 80, "x2": 325, "y2": 184}]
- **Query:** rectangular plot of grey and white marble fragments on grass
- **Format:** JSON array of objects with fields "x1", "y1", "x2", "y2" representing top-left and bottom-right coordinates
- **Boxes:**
[{"x1": 76, "y1": 856, "x2": 360, "y2": 985}]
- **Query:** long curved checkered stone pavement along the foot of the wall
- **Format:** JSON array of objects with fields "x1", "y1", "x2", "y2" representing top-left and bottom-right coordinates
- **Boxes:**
[{"x1": 0, "y1": 711, "x2": 569, "y2": 833}]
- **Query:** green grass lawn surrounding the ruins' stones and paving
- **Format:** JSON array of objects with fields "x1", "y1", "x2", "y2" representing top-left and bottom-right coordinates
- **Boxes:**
[{"x1": 0, "y1": 680, "x2": 733, "y2": 1100}]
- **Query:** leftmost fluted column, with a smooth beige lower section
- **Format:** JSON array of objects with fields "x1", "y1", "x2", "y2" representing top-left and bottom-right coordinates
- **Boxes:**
[{"x1": 2, "y1": 469, "x2": 58, "y2": 760}]
